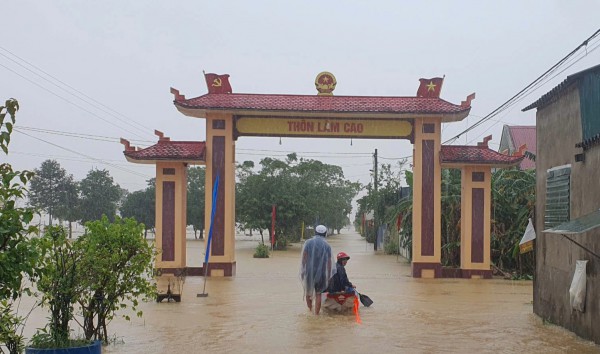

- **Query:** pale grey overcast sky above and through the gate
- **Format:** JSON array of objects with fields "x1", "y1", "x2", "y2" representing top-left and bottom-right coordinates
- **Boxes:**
[{"x1": 0, "y1": 0, "x2": 600, "y2": 198}]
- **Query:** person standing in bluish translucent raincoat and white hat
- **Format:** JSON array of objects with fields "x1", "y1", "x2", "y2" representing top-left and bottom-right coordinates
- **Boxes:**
[{"x1": 300, "y1": 225, "x2": 335, "y2": 315}]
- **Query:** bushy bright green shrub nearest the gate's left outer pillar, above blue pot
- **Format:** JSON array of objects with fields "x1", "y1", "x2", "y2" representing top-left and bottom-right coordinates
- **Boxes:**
[{"x1": 74, "y1": 215, "x2": 156, "y2": 341}]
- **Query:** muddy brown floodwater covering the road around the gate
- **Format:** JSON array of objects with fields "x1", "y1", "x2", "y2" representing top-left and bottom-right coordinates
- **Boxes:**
[{"x1": 21, "y1": 229, "x2": 600, "y2": 353}]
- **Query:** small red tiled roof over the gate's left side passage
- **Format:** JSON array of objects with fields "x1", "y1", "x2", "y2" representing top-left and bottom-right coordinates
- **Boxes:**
[{"x1": 123, "y1": 140, "x2": 206, "y2": 162}]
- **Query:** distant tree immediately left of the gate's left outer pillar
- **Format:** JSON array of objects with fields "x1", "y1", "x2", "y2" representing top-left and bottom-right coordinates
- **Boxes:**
[{"x1": 120, "y1": 178, "x2": 156, "y2": 237}]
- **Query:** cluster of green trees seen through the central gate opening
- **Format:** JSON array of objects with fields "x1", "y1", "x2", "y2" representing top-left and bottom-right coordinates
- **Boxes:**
[{"x1": 236, "y1": 154, "x2": 360, "y2": 242}]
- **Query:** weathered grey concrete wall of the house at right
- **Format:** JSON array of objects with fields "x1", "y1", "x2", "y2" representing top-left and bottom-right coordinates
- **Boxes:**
[{"x1": 533, "y1": 82, "x2": 600, "y2": 343}]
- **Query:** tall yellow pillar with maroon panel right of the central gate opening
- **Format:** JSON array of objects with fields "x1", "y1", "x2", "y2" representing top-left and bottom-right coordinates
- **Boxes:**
[{"x1": 412, "y1": 118, "x2": 442, "y2": 278}]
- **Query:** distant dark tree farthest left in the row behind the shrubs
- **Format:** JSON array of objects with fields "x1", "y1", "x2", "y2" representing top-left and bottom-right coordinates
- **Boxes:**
[{"x1": 29, "y1": 160, "x2": 67, "y2": 225}]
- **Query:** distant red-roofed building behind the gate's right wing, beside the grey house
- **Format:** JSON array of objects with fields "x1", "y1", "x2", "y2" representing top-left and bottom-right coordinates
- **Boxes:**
[{"x1": 498, "y1": 125, "x2": 537, "y2": 170}]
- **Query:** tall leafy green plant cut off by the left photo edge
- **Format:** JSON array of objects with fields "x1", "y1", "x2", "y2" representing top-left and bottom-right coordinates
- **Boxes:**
[{"x1": 0, "y1": 99, "x2": 40, "y2": 353}]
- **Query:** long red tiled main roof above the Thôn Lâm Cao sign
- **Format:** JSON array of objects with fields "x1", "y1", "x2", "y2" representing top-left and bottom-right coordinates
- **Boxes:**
[{"x1": 174, "y1": 101, "x2": 471, "y2": 123}]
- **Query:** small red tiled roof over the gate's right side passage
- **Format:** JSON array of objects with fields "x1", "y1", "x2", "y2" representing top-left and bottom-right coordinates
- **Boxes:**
[{"x1": 440, "y1": 145, "x2": 523, "y2": 167}]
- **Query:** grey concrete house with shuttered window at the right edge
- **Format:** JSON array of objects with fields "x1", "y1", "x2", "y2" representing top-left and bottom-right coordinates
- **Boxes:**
[{"x1": 523, "y1": 65, "x2": 600, "y2": 343}]
